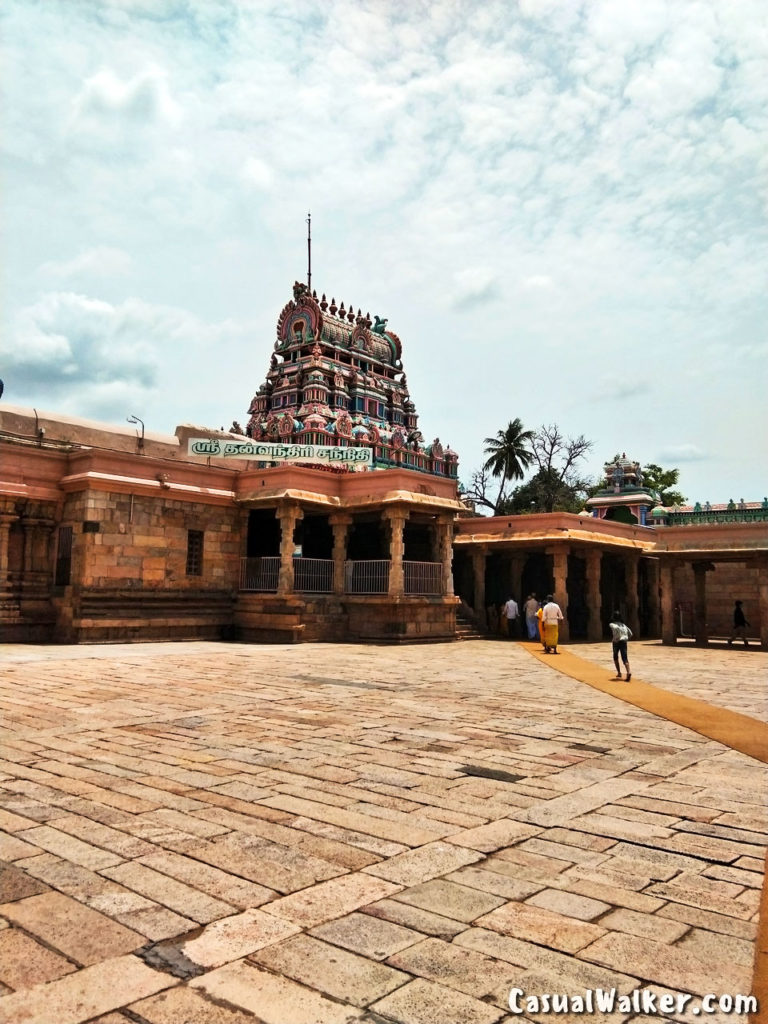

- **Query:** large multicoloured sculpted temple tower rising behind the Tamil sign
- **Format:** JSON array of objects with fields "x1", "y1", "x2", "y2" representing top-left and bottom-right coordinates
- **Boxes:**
[{"x1": 246, "y1": 282, "x2": 459, "y2": 478}]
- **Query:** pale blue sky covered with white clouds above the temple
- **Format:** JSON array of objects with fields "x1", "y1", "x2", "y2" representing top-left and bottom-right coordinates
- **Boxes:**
[{"x1": 0, "y1": 0, "x2": 768, "y2": 502}]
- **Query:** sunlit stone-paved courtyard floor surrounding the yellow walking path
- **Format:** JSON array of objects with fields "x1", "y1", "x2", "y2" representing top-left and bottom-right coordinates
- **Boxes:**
[{"x1": 0, "y1": 641, "x2": 768, "y2": 1024}]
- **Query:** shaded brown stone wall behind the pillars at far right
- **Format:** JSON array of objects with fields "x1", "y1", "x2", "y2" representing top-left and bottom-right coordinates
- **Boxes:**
[{"x1": 674, "y1": 562, "x2": 760, "y2": 638}]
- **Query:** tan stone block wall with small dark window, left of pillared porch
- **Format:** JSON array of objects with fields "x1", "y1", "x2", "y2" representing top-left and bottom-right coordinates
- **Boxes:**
[{"x1": 56, "y1": 492, "x2": 243, "y2": 642}]
